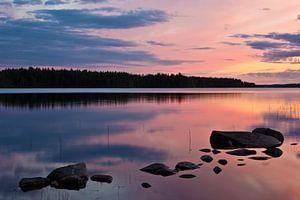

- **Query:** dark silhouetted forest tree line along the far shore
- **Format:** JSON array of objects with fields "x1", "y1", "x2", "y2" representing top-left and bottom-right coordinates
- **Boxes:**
[{"x1": 0, "y1": 67, "x2": 255, "y2": 88}]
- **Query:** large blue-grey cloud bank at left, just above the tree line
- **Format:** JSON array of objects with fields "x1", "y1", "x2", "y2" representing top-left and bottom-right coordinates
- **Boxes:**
[{"x1": 0, "y1": 17, "x2": 202, "y2": 66}]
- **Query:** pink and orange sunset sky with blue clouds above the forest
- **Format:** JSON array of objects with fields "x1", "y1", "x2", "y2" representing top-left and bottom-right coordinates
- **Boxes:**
[{"x1": 0, "y1": 0, "x2": 300, "y2": 84}]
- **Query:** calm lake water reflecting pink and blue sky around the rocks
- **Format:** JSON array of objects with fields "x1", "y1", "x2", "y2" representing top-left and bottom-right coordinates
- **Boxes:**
[{"x1": 0, "y1": 89, "x2": 300, "y2": 200}]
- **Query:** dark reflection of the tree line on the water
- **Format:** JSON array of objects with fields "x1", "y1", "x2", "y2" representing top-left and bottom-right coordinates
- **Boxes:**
[{"x1": 0, "y1": 93, "x2": 242, "y2": 109}]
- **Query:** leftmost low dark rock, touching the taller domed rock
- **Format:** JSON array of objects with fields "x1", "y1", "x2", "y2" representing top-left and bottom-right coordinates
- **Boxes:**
[{"x1": 19, "y1": 177, "x2": 50, "y2": 192}]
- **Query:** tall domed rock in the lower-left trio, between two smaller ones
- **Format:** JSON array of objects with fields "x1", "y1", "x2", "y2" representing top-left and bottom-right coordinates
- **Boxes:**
[{"x1": 47, "y1": 163, "x2": 88, "y2": 190}]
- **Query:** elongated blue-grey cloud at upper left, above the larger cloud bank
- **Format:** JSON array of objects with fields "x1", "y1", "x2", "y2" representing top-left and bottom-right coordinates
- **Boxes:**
[{"x1": 33, "y1": 9, "x2": 169, "y2": 29}]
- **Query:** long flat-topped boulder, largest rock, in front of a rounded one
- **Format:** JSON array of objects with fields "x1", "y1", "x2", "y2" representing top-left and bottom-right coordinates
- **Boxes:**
[{"x1": 210, "y1": 131, "x2": 283, "y2": 149}]
